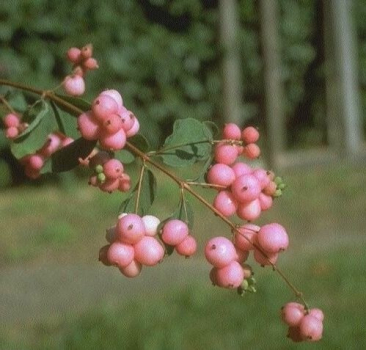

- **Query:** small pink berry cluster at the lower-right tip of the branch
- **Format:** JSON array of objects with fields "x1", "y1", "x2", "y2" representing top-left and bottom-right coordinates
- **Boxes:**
[{"x1": 281, "y1": 302, "x2": 324, "y2": 342}]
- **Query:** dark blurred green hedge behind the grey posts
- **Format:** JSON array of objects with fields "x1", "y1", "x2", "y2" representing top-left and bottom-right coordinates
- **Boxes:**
[{"x1": 0, "y1": 0, "x2": 366, "y2": 186}]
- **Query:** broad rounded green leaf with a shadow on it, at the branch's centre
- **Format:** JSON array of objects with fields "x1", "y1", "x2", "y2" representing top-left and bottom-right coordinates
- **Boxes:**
[{"x1": 161, "y1": 118, "x2": 212, "y2": 167}]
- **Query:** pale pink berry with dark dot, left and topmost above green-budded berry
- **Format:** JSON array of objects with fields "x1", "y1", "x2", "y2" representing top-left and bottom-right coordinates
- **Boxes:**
[{"x1": 205, "y1": 237, "x2": 236, "y2": 268}]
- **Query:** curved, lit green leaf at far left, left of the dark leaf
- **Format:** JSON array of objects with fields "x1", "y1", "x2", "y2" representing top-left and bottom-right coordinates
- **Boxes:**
[{"x1": 10, "y1": 103, "x2": 57, "y2": 159}]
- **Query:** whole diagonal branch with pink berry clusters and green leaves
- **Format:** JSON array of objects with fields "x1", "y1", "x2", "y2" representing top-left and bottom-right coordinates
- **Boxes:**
[{"x1": 0, "y1": 45, "x2": 324, "y2": 342}]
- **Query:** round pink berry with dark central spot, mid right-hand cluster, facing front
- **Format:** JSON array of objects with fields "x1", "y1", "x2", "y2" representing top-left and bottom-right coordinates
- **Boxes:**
[{"x1": 231, "y1": 174, "x2": 261, "y2": 203}]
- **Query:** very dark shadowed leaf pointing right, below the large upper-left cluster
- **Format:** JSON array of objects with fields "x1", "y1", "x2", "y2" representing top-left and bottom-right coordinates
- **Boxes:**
[{"x1": 51, "y1": 137, "x2": 97, "y2": 173}]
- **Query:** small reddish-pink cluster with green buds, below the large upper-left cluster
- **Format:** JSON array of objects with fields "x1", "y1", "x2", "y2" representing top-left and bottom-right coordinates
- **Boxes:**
[{"x1": 88, "y1": 151, "x2": 131, "y2": 193}]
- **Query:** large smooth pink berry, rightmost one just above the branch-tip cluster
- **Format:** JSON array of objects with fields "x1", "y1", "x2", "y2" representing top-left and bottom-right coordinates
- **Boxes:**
[{"x1": 257, "y1": 223, "x2": 289, "y2": 253}]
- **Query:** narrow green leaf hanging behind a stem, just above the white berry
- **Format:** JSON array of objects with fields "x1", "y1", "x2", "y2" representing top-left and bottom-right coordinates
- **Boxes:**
[{"x1": 119, "y1": 168, "x2": 156, "y2": 216}]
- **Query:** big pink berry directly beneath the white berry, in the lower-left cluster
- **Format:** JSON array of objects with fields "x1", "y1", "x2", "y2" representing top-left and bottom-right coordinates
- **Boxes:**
[{"x1": 134, "y1": 236, "x2": 165, "y2": 266}]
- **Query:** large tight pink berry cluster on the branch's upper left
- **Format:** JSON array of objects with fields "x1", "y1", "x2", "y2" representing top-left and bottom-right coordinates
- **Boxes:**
[{"x1": 77, "y1": 90, "x2": 140, "y2": 151}]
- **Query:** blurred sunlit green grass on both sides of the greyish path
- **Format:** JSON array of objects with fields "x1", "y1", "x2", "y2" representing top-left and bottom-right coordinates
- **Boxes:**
[{"x1": 0, "y1": 166, "x2": 366, "y2": 350}]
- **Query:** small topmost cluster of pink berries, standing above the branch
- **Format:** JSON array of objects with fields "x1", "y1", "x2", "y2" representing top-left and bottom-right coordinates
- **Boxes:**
[{"x1": 63, "y1": 44, "x2": 98, "y2": 96}]
